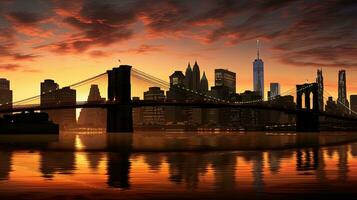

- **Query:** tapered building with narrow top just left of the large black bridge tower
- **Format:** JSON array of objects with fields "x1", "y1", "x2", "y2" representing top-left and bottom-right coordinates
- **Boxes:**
[{"x1": 78, "y1": 85, "x2": 107, "y2": 128}]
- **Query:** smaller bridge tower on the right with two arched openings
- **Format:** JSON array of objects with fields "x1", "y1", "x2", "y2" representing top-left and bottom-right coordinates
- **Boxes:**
[{"x1": 296, "y1": 83, "x2": 319, "y2": 132}]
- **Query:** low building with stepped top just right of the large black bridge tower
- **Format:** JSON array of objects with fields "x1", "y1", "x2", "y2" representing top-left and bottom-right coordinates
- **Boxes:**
[{"x1": 143, "y1": 87, "x2": 165, "y2": 125}]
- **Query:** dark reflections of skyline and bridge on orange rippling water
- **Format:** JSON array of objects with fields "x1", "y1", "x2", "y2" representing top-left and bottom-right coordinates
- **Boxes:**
[{"x1": 0, "y1": 140, "x2": 357, "y2": 192}]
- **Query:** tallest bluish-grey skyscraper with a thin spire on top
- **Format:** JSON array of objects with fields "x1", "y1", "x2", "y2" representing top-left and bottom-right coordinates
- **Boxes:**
[{"x1": 253, "y1": 40, "x2": 264, "y2": 98}]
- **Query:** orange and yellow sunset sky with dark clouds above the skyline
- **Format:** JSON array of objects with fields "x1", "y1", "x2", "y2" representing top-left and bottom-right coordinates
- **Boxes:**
[{"x1": 0, "y1": 0, "x2": 357, "y2": 101}]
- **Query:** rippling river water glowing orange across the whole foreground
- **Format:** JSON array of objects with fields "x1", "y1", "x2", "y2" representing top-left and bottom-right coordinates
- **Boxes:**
[{"x1": 0, "y1": 132, "x2": 357, "y2": 199}]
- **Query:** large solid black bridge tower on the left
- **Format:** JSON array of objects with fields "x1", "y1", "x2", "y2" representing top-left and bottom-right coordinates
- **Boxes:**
[{"x1": 107, "y1": 65, "x2": 133, "y2": 132}]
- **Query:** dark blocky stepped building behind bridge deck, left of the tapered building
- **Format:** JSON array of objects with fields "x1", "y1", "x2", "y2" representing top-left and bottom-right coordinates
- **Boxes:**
[{"x1": 40, "y1": 79, "x2": 77, "y2": 127}]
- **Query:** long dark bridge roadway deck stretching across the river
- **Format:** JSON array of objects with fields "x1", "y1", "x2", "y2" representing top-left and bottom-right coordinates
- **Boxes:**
[{"x1": 0, "y1": 100, "x2": 357, "y2": 122}]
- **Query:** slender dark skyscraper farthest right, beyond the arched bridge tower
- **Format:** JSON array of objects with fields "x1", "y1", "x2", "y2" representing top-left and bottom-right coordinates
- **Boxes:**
[{"x1": 337, "y1": 70, "x2": 349, "y2": 113}]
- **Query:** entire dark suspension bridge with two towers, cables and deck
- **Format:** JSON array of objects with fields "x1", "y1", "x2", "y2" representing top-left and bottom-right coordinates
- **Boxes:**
[{"x1": 0, "y1": 65, "x2": 357, "y2": 132}]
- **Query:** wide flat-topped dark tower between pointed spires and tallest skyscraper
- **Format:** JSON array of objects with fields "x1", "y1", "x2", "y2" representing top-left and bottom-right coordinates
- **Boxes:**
[{"x1": 214, "y1": 69, "x2": 236, "y2": 94}]
